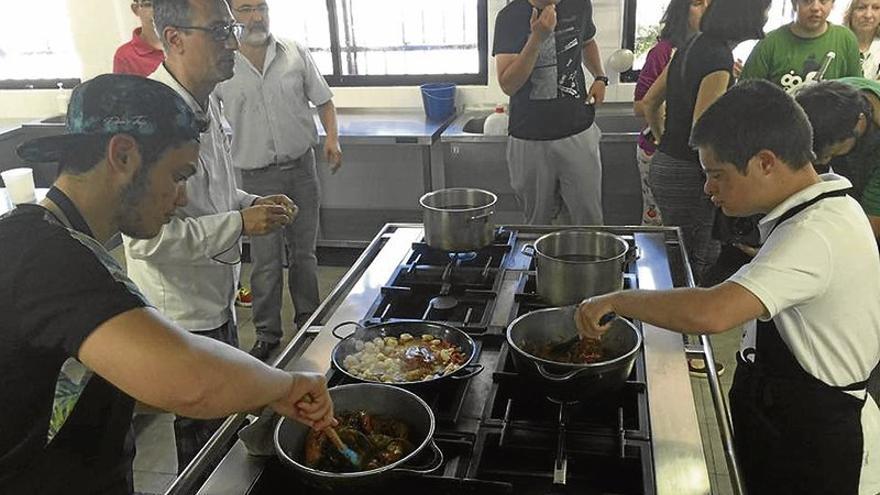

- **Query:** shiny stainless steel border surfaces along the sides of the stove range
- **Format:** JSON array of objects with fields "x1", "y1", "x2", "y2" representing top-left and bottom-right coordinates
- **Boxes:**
[{"x1": 167, "y1": 224, "x2": 710, "y2": 495}]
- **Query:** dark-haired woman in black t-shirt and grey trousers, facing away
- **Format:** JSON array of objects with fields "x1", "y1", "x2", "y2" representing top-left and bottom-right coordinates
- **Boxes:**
[{"x1": 643, "y1": 0, "x2": 770, "y2": 284}]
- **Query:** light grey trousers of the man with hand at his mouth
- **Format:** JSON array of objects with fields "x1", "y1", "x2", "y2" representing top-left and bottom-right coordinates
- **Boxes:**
[{"x1": 507, "y1": 124, "x2": 603, "y2": 225}]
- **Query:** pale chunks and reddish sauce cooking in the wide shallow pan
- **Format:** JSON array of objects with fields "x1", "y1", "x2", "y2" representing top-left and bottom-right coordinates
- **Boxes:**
[{"x1": 342, "y1": 333, "x2": 467, "y2": 383}]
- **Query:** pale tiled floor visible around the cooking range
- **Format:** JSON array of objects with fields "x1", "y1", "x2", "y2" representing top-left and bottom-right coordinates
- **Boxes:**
[{"x1": 134, "y1": 264, "x2": 740, "y2": 495}]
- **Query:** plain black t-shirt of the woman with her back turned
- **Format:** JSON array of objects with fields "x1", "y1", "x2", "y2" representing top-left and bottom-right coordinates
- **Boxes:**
[{"x1": 660, "y1": 34, "x2": 733, "y2": 164}]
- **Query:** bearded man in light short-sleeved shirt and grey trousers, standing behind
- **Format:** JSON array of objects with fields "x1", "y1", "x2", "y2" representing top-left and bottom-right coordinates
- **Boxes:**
[{"x1": 215, "y1": 0, "x2": 342, "y2": 359}]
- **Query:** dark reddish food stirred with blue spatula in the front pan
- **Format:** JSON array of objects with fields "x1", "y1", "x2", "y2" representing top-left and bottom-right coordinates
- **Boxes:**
[{"x1": 305, "y1": 411, "x2": 414, "y2": 473}]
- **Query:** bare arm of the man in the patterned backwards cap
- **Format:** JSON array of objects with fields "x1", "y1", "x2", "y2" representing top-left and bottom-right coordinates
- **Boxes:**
[{"x1": 78, "y1": 308, "x2": 292, "y2": 418}]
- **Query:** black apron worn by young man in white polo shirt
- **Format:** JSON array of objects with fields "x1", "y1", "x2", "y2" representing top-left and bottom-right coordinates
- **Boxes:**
[{"x1": 730, "y1": 190, "x2": 867, "y2": 495}]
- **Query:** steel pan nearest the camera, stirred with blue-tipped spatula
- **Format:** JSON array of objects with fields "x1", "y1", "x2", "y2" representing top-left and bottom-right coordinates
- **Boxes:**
[{"x1": 274, "y1": 383, "x2": 443, "y2": 490}]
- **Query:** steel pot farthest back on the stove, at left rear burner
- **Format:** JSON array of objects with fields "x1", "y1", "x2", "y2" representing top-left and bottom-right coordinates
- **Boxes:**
[{"x1": 419, "y1": 187, "x2": 498, "y2": 253}]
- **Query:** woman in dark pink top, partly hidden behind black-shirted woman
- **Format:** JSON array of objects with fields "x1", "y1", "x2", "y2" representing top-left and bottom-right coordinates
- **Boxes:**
[{"x1": 633, "y1": 0, "x2": 708, "y2": 225}]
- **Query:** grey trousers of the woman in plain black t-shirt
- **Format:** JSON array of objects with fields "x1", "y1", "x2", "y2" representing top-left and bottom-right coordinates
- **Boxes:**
[{"x1": 650, "y1": 151, "x2": 721, "y2": 285}]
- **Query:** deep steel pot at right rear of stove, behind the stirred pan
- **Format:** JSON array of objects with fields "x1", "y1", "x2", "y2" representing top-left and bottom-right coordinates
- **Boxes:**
[{"x1": 522, "y1": 229, "x2": 636, "y2": 306}]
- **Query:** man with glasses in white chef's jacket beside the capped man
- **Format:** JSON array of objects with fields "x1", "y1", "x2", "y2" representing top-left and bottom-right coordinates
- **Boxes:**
[{"x1": 124, "y1": 0, "x2": 296, "y2": 471}]
